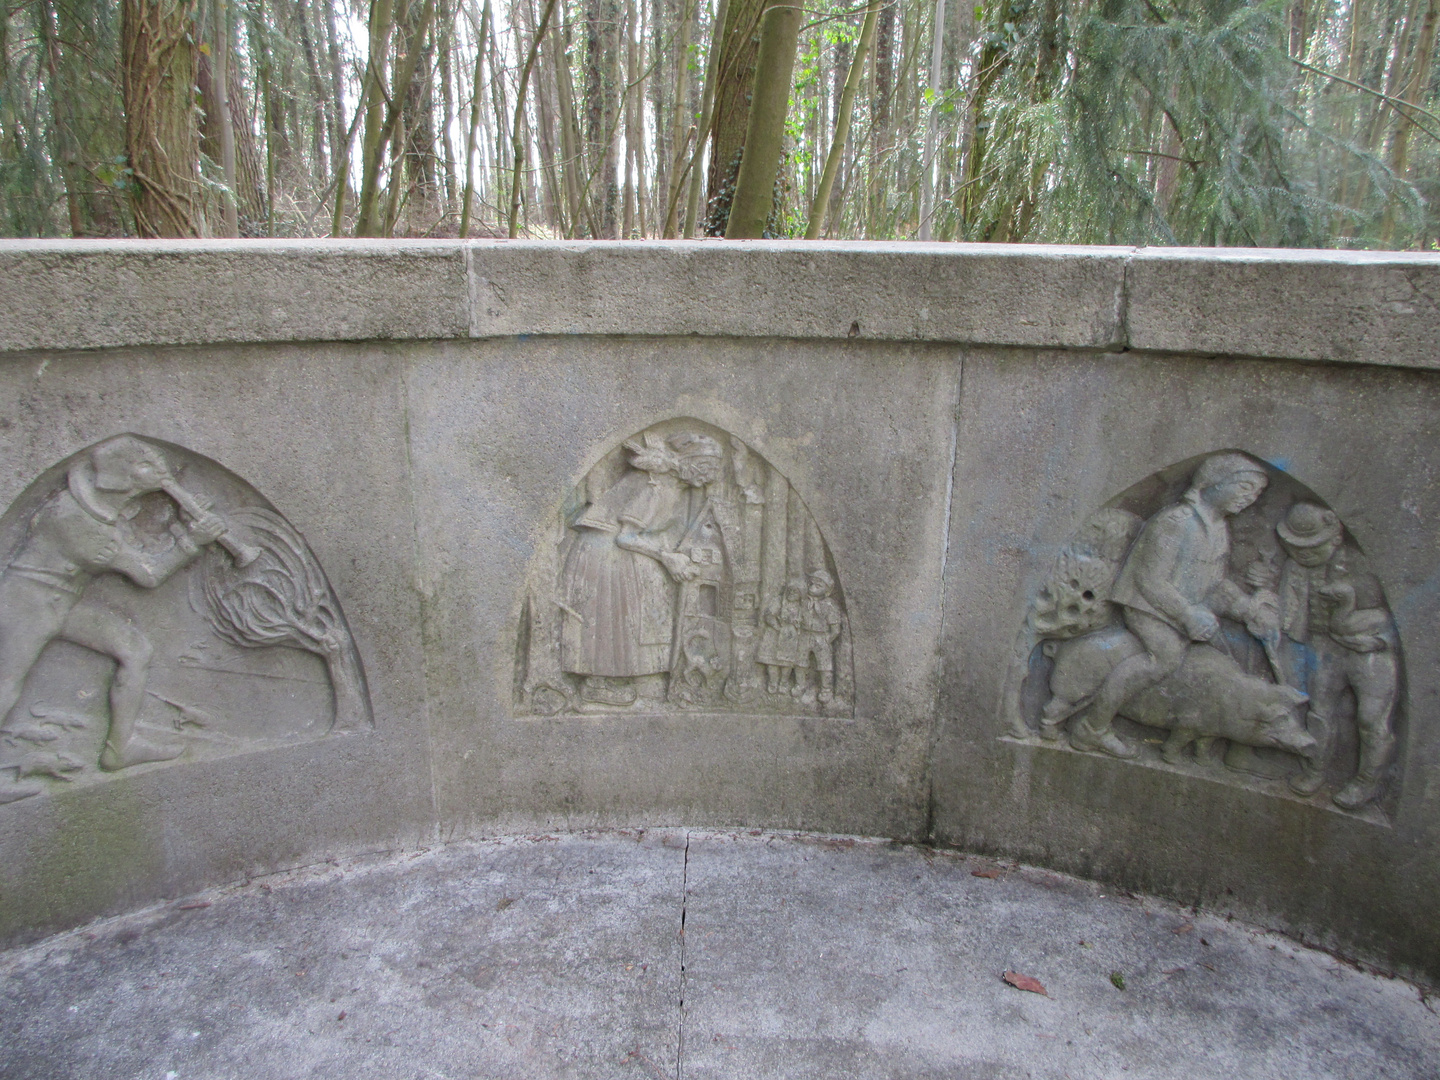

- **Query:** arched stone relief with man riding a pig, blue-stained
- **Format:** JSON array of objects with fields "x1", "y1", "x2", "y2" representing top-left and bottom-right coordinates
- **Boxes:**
[{"x1": 1004, "y1": 452, "x2": 1401, "y2": 812}]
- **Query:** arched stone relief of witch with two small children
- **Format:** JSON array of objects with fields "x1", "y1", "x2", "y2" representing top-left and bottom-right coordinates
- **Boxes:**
[{"x1": 516, "y1": 419, "x2": 854, "y2": 716}]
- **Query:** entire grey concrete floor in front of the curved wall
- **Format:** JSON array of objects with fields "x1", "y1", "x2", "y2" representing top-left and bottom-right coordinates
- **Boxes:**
[{"x1": 0, "y1": 829, "x2": 1440, "y2": 1080}]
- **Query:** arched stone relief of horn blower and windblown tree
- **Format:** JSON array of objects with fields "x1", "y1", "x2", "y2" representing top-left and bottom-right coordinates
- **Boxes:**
[{"x1": 0, "y1": 435, "x2": 373, "y2": 802}]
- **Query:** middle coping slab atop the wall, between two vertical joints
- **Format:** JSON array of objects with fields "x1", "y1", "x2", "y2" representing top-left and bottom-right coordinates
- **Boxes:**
[{"x1": 465, "y1": 240, "x2": 1129, "y2": 348}]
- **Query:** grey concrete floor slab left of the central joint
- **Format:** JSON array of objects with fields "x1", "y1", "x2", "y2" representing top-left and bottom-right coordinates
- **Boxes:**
[{"x1": 0, "y1": 832, "x2": 685, "y2": 1080}]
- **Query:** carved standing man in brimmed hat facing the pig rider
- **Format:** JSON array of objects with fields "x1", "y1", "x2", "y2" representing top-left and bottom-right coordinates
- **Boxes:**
[{"x1": 1276, "y1": 503, "x2": 1400, "y2": 809}]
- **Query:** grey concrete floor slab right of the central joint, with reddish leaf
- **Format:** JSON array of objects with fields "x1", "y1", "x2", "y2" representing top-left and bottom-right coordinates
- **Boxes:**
[{"x1": 683, "y1": 835, "x2": 1437, "y2": 1080}]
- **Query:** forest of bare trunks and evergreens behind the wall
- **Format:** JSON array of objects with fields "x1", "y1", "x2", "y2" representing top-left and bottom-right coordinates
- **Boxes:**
[{"x1": 0, "y1": 0, "x2": 1440, "y2": 251}]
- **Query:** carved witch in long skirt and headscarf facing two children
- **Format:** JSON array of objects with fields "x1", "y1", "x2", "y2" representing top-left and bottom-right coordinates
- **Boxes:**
[{"x1": 560, "y1": 432, "x2": 721, "y2": 706}]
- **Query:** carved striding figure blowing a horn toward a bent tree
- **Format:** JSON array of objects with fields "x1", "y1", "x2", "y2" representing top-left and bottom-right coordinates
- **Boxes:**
[{"x1": 0, "y1": 435, "x2": 256, "y2": 770}]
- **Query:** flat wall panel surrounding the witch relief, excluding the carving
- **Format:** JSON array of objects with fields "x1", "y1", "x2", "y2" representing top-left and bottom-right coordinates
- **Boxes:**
[{"x1": 408, "y1": 338, "x2": 959, "y2": 837}]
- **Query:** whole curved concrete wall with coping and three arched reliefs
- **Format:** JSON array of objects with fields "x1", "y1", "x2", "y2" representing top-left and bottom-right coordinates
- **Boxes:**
[{"x1": 0, "y1": 242, "x2": 1440, "y2": 978}]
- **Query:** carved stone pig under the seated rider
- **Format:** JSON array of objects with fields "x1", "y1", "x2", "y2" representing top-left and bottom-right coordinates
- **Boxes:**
[{"x1": 1045, "y1": 626, "x2": 1316, "y2": 763}]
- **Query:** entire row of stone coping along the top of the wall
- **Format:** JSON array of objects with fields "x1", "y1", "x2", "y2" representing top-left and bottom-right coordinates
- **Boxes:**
[{"x1": 0, "y1": 240, "x2": 1440, "y2": 369}]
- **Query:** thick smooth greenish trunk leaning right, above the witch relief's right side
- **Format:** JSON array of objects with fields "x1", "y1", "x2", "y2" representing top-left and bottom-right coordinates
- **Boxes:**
[{"x1": 724, "y1": 3, "x2": 801, "y2": 240}]
